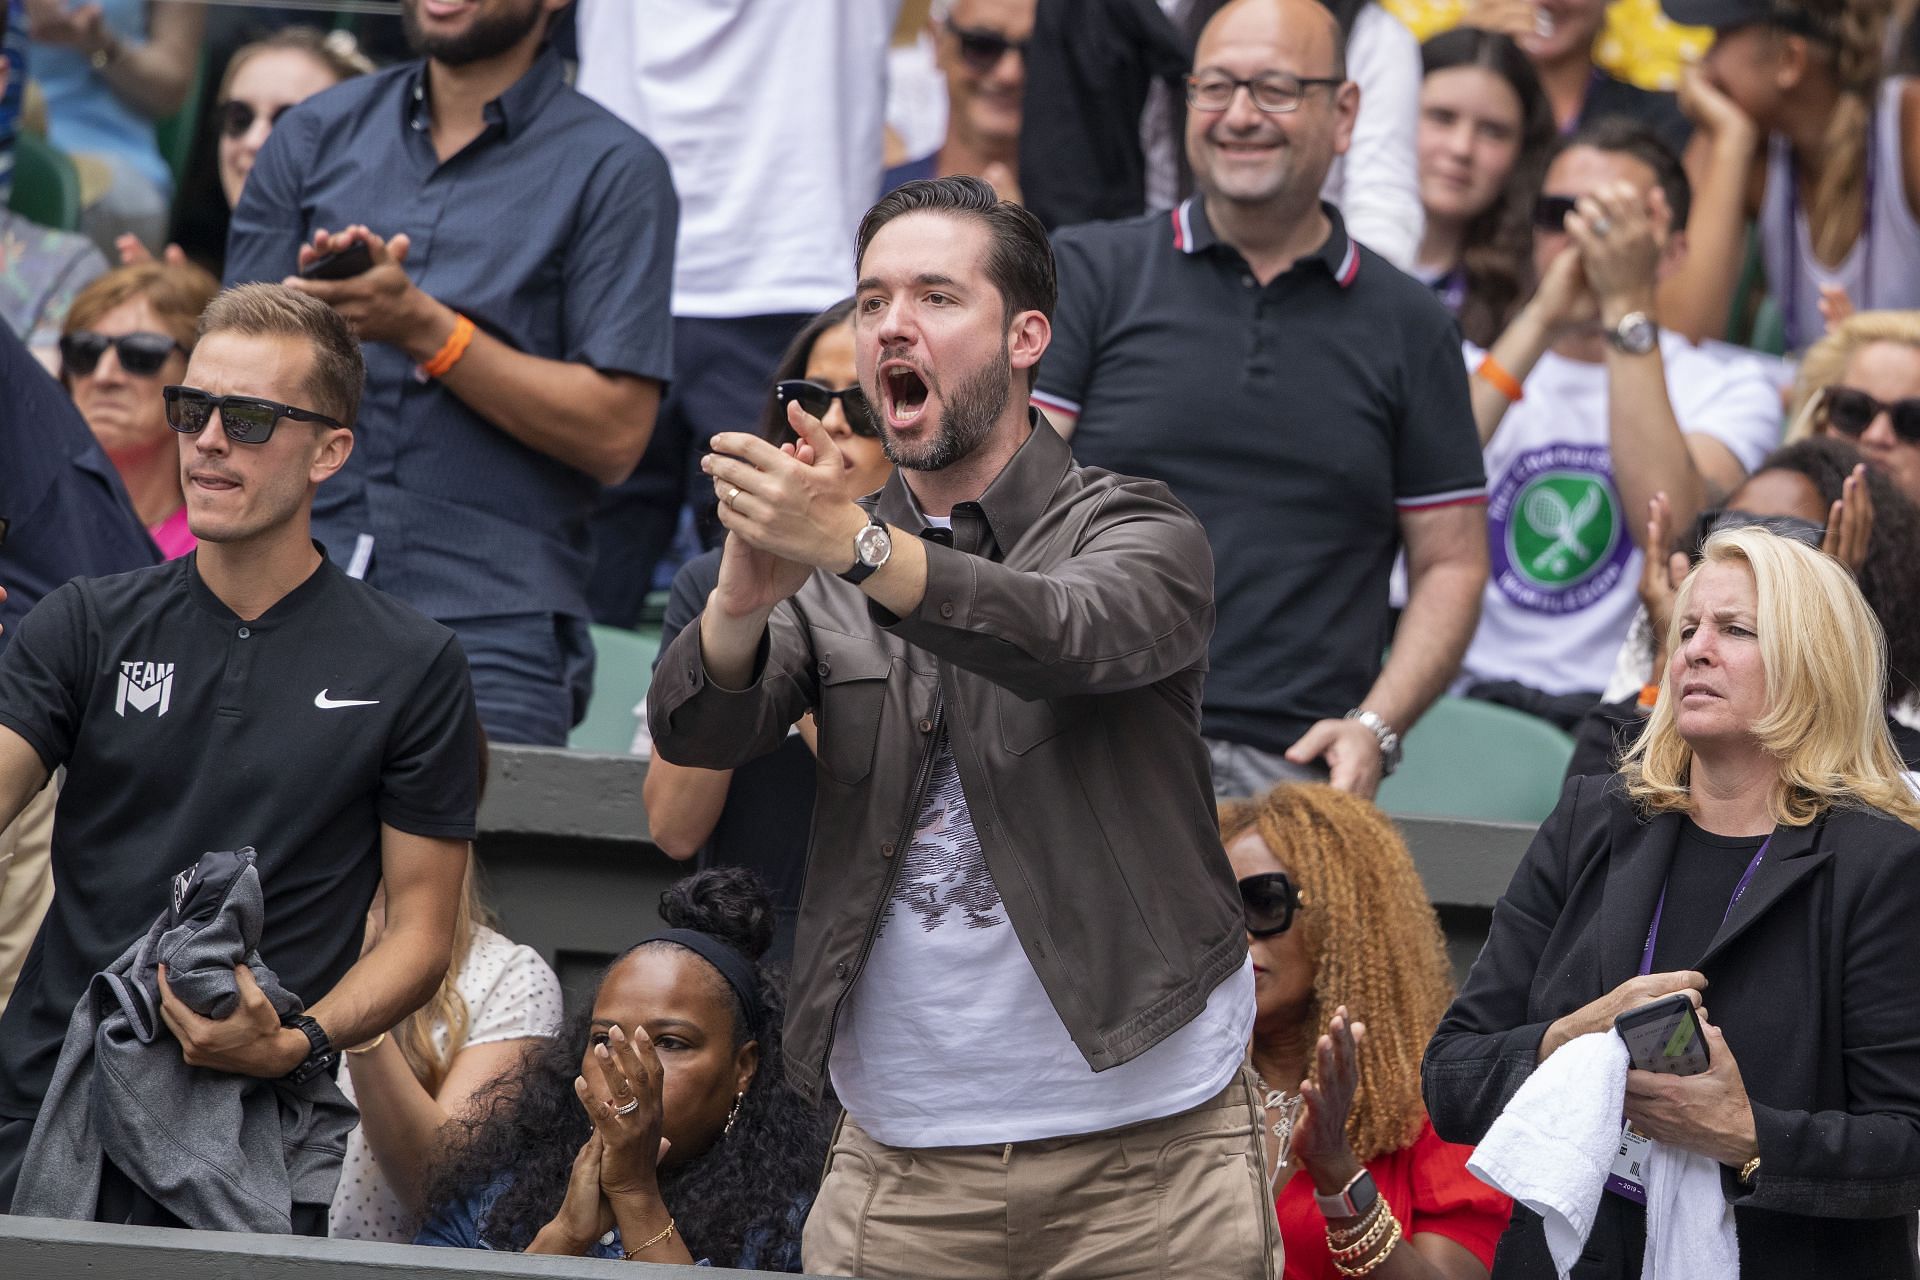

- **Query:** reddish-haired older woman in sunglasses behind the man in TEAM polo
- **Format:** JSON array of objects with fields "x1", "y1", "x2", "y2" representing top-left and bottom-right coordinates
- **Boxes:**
[{"x1": 60, "y1": 263, "x2": 221, "y2": 560}]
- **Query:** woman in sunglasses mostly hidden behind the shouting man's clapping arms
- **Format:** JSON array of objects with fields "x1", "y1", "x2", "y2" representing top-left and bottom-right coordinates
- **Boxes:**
[{"x1": 634, "y1": 297, "x2": 893, "y2": 958}]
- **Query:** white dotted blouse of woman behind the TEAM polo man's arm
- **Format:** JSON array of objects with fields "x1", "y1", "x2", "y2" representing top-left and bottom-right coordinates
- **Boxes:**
[{"x1": 326, "y1": 925, "x2": 561, "y2": 1244}]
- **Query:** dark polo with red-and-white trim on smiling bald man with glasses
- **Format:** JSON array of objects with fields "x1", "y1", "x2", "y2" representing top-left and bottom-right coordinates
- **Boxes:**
[{"x1": 1033, "y1": 198, "x2": 1486, "y2": 750}]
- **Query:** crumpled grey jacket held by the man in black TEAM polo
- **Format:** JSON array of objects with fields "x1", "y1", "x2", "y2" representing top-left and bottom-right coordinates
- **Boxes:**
[{"x1": 13, "y1": 848, "x2": 357, "y2": 1234}]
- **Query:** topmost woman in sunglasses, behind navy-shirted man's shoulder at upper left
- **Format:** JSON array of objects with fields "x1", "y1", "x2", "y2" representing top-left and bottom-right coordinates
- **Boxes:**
[{"x1": 115, "y1": 27, "x2": 372, "y2": 263}]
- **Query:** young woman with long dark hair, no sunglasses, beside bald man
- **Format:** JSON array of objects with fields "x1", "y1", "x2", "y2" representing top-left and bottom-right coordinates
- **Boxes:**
[{"x1": 1415, "y1": 27, "x2": 1553, "y2": 347}]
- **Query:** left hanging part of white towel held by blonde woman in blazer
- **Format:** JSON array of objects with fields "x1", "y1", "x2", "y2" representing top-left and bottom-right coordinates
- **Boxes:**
[{"x1": 1467, "y1": 1031, "x2": 1626, "y2": 1280}]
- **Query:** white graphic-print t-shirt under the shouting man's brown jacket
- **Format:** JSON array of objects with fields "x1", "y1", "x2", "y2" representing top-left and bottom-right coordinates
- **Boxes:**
[{"x1": 831, "y1": 733, "x2": 1254, "y2": 1148}]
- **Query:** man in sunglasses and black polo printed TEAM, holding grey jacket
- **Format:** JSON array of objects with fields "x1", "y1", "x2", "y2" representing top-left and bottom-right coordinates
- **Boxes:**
[{"x1": 0, "y1": 284, "x2": 478, "y2": 1232}]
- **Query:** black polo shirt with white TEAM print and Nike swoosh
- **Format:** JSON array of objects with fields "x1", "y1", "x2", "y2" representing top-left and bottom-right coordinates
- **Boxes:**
[{"x1": 0, "y1": 553, "x2": 480, "y2": 1117}]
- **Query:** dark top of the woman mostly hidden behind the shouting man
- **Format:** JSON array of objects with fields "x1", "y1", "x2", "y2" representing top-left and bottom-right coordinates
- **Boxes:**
[{"x1": 655, "y1": 547, "x2": 814, "y2": 961}]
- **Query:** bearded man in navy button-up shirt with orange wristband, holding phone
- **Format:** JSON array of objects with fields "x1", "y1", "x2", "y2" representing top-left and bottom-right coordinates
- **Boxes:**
[{"x1": 227, "y1": 0, "x2": 678, "y2": 745}]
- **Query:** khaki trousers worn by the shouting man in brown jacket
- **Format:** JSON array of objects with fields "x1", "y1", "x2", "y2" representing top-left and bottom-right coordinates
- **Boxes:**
[{"x1": 801, "y1": 1069, "x2": 1281, "y2": 1280}]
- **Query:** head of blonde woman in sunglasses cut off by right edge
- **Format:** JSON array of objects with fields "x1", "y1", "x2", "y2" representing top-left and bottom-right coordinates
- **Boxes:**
[{"x1": 1788, "y1": 311, "x2": 1920, "y2": 503}]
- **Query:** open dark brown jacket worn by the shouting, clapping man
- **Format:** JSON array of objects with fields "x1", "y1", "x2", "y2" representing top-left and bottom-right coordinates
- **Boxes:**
[{"x1": 649, "y1": 415, "x2": 1246, "y2": 1098}]
